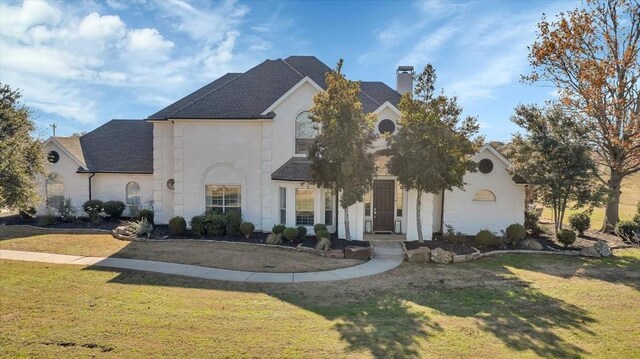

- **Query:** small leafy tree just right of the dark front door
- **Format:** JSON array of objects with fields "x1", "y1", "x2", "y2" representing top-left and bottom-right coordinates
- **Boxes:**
[{"x1": 388, "y1": 65, "x2": 482, "y2": 241}]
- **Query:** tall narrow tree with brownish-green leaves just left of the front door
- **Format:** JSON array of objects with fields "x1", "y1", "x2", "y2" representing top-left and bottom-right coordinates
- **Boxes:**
[{"x1": 308, "y1": 59, "x2": 376, "y2": 240}]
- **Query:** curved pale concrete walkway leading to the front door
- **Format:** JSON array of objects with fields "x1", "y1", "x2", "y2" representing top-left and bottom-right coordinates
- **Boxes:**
[{"x1": 0, "y1": 243, "x2": 404, "y2": 283}]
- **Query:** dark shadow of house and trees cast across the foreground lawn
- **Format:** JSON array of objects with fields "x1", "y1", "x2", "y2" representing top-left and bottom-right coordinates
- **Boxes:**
[{"x1": 87, "y1": 255, "x2": 595, "y2": 358}]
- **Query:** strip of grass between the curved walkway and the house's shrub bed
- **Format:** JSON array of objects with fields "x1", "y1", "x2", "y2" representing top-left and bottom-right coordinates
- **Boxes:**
[{"x1": 0, "y1": 226, "x2": 362, "y2": 272}]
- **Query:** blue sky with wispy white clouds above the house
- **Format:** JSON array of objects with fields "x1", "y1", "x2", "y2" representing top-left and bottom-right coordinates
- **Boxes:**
[{"x1": 0, "y1": 0, "x2": 577, "y2": 140}]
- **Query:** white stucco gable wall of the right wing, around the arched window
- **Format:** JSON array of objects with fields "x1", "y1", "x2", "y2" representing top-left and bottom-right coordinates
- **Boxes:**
[{"x1": 444, "y1": 149, "x2": 525, "y2": 234}]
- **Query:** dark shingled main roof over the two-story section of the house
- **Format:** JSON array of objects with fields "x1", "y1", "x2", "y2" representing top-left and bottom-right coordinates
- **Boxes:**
[{"x1": 148, "y1": 56, "x2": 400, "y2": 120}]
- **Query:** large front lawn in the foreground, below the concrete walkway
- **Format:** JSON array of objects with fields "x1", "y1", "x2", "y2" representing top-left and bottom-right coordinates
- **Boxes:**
[{"x1": 0, "y1": 249, "x2": 640, "y2": 358}]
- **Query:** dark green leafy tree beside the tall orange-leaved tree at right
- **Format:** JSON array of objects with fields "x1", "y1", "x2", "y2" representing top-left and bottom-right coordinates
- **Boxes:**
[{"x1": 511, "y1": 105, "x2": 604, "y2": 234}]
